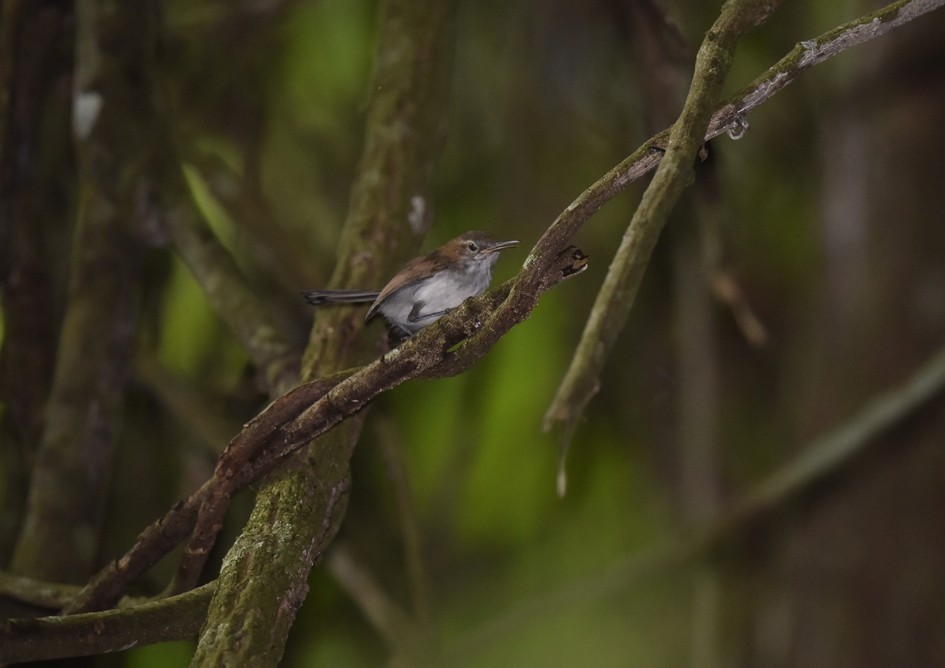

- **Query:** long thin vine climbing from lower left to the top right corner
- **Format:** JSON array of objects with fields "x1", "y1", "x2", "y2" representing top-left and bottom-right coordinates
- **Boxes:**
[{"x1": 59, "y1": 0, "x2": 945, "y2": 611}]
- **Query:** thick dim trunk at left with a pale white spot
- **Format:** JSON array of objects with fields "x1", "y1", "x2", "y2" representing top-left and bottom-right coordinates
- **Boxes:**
[{"x1": 11, "y1": 0, "x2": 155, "y2": 582}]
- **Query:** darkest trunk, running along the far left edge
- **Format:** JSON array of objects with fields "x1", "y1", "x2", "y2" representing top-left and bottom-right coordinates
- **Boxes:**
[{"x1": 0, "y1": 0, "x2": 63, "y2": 563}]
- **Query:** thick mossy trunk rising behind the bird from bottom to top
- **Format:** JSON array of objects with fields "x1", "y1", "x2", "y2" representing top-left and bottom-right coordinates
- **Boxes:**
[{"x1": 194, "y1": 0, "x2": 453, "y2": 666}]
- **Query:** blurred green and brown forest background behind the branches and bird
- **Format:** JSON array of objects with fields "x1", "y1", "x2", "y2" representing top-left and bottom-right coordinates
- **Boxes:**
[{"x1": 0, "y1": 0, "x2": 945, "y2": 668}]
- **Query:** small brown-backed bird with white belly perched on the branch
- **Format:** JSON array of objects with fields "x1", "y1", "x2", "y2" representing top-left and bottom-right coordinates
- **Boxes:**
[{"x1": 302, "y1": 232, "x2": 518, "y2": 338}]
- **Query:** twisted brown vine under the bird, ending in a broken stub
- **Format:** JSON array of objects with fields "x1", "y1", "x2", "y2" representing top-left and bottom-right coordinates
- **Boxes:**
[{"x1": 60, "y1": 243, "x2": 585, "y2": 613}]
